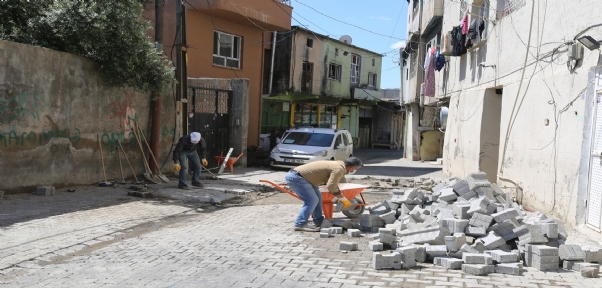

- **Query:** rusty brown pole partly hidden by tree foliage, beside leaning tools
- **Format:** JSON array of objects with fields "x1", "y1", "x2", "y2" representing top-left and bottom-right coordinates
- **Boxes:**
[{"x1": 148, "y1": 0, "x2": 165, "y2": 173}]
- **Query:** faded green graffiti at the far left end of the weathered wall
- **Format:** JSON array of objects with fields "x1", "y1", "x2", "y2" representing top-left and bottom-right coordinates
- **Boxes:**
[{"x1": 0, "y1": 93, "x2": 50, "y2": 124}]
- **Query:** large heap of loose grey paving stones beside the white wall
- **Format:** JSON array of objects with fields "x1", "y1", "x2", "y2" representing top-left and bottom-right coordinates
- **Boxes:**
[{"x1": 323, "y1": 172, "x2": 602, "y2": 277}]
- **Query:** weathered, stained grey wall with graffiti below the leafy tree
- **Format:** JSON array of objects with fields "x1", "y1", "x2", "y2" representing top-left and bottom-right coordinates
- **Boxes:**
[{"x1": 0, "y1": 41, "x2": 174, "y2": 193}]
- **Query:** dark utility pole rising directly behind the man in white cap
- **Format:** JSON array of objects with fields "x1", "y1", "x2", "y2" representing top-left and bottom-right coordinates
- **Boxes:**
[{"x1": 175, "y1": 0, "x2": 188, "y2": 135}]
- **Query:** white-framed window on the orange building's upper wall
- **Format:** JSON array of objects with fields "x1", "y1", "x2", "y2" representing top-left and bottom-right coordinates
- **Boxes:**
[{"x1": 213, "y1": 31, "x2": 241, "y2": 68}]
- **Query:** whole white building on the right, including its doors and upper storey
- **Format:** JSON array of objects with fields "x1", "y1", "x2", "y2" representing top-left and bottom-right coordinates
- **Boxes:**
[{"x1": 402, "y1": 0, "x2": 602, "y2": 231}]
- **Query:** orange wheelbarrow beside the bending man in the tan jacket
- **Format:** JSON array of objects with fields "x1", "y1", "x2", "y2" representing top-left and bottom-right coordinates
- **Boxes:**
[{"x1": 259, "y1": 180, "x2": 368, "y2": 219}]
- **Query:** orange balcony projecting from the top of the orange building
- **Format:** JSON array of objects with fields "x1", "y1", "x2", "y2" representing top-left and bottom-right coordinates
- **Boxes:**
[{"x1": 186, "y1": 0, "x2": 293, "y2": 31}]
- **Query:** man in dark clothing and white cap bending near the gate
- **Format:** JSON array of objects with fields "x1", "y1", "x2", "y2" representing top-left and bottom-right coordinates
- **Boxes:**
[{"x1": 173, "y1": 132, "x2": 208, "y2": 190}]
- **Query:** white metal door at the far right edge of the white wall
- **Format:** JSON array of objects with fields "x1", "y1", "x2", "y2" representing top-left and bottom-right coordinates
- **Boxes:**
[{"x1": 587, "y1": 74, "x2": 602, "y2": 232}]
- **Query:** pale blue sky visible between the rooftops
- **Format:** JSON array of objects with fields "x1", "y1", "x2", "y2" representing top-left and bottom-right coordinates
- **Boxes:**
[{"x1": 291, "y1": 0, "x2": 408, "y2": 89}]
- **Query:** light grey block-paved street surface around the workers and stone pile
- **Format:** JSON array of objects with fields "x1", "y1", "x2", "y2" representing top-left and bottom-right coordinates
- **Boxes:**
[{"x1": 0, "y1": 151, "x2": 602, "y2": 287}]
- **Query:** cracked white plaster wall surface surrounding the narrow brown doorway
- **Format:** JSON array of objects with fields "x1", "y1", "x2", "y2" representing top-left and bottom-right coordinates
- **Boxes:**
[{"x1": 437, "y1": 0, "x2": 602, "y2": 225}]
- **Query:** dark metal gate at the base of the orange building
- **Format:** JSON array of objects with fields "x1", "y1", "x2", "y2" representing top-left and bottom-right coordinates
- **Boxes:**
[{"x1": 188, "y1": 86, "x2": 232, "y2": 167}]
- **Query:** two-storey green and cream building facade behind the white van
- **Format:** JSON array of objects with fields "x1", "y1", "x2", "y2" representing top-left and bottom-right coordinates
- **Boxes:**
[{"x1": 261, "y1": 26, "x2": 382, "y2": 144}]
